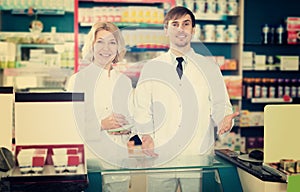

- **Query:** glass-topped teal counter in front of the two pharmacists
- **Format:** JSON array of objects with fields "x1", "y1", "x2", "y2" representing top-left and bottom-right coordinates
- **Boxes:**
[{"x1": 86, "y1": 155, "x2": 242, "y2": 192}]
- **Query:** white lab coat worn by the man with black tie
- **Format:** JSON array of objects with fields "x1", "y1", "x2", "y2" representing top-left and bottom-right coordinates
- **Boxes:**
[{"x1": 134, "y1": 49, "x2": 232, "y2": 164}]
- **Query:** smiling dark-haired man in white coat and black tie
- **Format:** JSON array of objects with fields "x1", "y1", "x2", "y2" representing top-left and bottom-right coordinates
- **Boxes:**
[{"x1": 134, "y1": 6, "x2": 238, "y2": 192}]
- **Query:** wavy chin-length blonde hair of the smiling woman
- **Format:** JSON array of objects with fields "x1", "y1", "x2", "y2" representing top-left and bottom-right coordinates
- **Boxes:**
[{"x1": 82, "y1": 22, "x2": 126, "y2": 63}]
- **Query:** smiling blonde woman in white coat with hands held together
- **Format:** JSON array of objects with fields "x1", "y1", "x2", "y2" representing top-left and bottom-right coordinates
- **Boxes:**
[{"x1": 67, "y1": 22, "x2": 132, "y2": 191}]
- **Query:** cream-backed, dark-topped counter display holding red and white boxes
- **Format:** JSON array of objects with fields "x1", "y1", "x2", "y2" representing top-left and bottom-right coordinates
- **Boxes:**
[{"x1": 4, "y1": 92, "x2": 88, "y2": 191}]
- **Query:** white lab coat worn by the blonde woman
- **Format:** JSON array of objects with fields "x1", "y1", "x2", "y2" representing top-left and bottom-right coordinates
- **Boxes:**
[{"x1": 66, "y1": 63, "x2": 133, "y2": 150}]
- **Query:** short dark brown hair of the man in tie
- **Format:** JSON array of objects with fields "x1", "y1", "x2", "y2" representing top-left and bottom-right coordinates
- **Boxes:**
[{"x1": 164, "y1": 6, "x2": 196, "y2": 28}]
